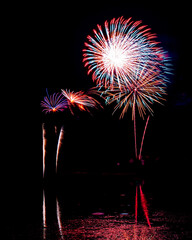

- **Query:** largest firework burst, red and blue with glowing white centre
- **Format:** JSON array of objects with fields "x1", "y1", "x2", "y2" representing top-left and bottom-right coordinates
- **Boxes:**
[{"x1": 83, "y1": 17, "x2": 169, "y2": 89}]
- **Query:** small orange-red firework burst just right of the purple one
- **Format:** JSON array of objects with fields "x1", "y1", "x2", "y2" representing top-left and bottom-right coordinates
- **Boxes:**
[{"x1": 61, "y1": 89, "x2": 100, "y2": 114}]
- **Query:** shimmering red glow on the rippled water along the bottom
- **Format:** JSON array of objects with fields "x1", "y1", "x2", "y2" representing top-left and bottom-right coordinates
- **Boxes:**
[{"x1": 40, "y1": 211, "x2": 191, "y2": 240}]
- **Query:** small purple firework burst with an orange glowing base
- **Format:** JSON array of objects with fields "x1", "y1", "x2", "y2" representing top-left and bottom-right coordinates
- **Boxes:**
[{"x1": 41, "y1": 92, "x2": 68, "y2": 113}]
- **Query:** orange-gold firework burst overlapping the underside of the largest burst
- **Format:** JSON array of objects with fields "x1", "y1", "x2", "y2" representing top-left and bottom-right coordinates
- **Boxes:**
[{"x1": 98, "y1": 65, "x2": 166, "y2": 119}]
